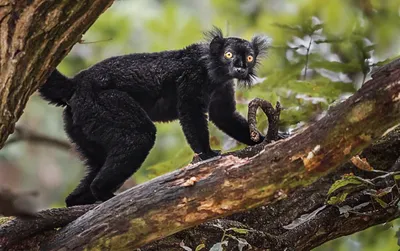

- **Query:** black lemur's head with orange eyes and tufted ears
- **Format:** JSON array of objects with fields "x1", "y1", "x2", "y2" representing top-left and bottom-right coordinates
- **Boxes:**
[{"x1": 206, "y1": 27, "x2": 268, "y2": 85}]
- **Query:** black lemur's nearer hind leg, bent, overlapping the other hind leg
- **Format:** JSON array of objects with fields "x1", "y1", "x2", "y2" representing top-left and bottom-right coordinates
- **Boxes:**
[{"x1": 79, "y1": 90, "x2": 156, "y2": 201}]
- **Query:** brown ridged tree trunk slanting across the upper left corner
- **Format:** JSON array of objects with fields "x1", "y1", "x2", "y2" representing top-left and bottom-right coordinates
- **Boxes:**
[{"x1": 0, "y1": 0, "x2": 113, "y2": 148}]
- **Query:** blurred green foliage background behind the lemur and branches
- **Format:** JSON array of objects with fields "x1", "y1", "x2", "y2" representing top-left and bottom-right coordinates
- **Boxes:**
[{"x1": 0, "y1": 0, "x2": 400, "y2": 251}]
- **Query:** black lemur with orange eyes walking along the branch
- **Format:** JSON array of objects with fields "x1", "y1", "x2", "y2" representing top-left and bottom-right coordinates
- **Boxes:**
[{"x1": 39, "y1": 28, "x2": 268, "y2": 206}]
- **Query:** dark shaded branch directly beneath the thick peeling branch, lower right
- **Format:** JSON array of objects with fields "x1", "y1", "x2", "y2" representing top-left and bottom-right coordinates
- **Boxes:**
[{"x1": 141, "y1": 127, "x2": 400, "y2": 251}]
